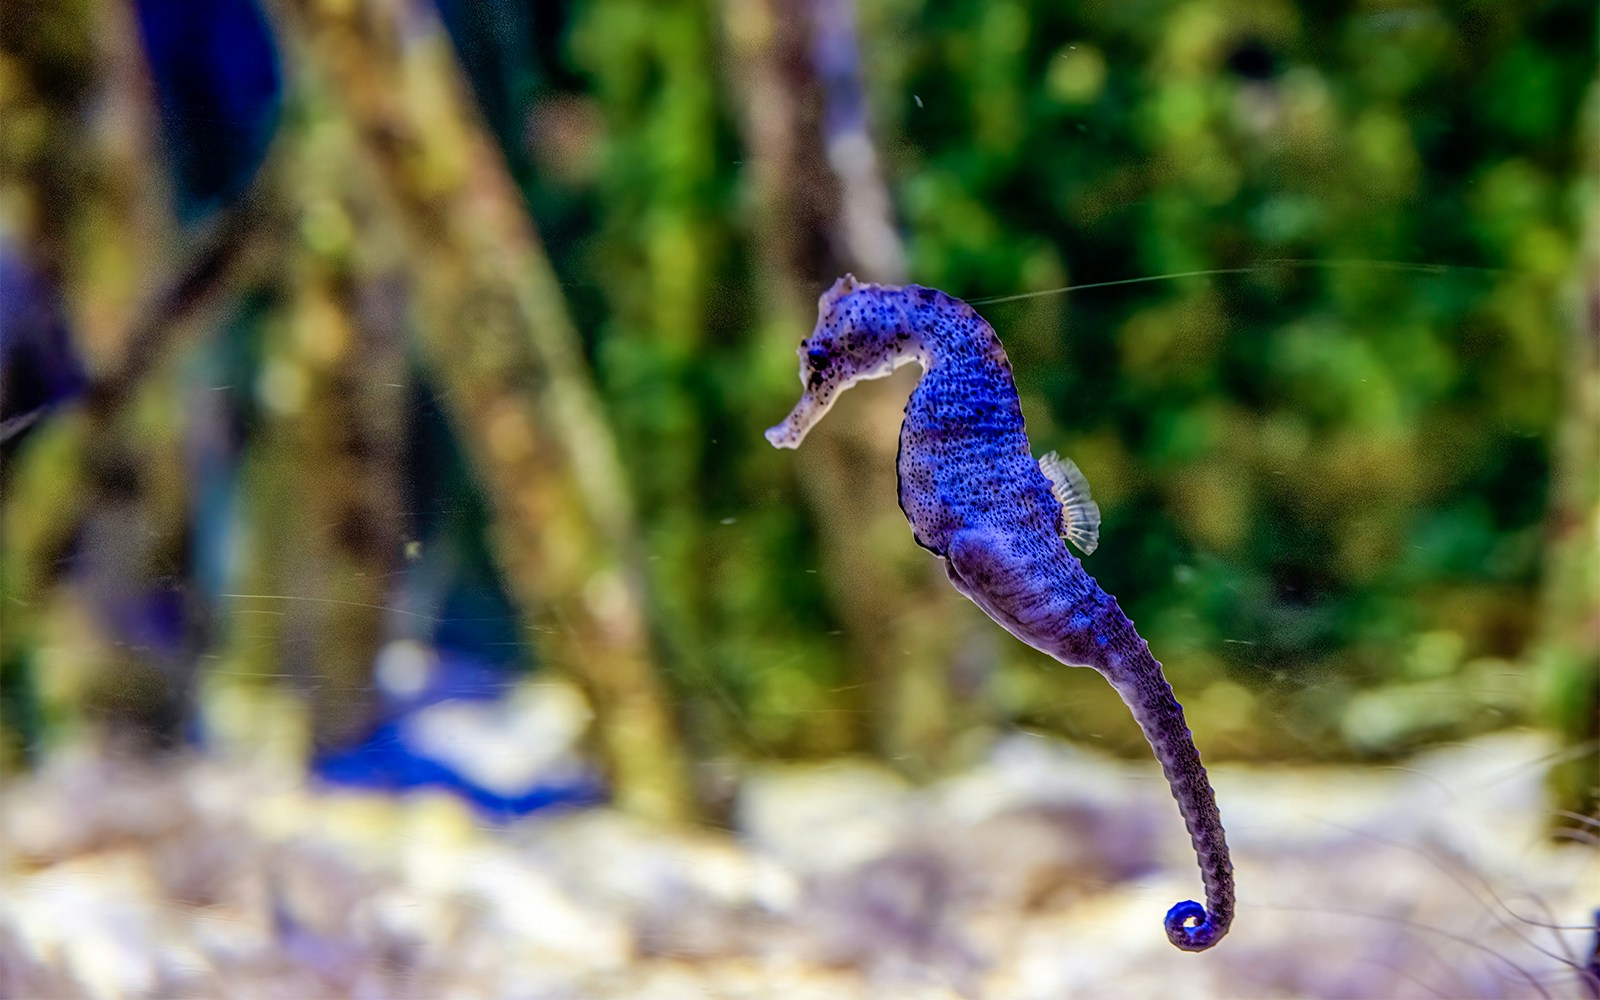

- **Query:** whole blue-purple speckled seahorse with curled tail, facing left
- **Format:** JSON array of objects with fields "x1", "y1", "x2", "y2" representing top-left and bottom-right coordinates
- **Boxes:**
[{"x1": 766, "y1": 274, "x2": 1234, "y2": 952}]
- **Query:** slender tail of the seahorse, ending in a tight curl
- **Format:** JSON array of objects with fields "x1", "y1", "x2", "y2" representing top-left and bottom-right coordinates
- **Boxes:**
[{"x1": 1104, "y1": 636, "x2": 1234, "y2": 952}]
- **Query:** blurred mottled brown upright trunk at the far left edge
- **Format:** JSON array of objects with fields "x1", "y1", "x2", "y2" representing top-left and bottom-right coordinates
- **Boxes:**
[{"x1": 0, "y1": 2, "x2": 259, "y2": 746}]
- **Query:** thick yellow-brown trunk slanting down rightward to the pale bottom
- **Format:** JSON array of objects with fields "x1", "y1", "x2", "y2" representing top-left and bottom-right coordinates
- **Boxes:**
[{"x1": 273, "y1": 0, "x2": 691, "y2": 819}]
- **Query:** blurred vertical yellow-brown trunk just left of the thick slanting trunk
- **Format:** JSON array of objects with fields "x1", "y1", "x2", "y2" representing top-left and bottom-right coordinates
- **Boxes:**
[{"x1": 268, "y1": 107, "x2": 408, "y2": 749}]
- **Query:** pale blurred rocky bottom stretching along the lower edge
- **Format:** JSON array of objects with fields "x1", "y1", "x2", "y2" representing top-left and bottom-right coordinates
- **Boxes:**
[{"x1": 0, "y1": 733, "x2": 1600, "y2": 1000}]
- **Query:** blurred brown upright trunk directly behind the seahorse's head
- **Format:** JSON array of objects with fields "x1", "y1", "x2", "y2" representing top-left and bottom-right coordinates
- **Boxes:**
[{"x1": 722, "y1": 0, "x2": 962, "y2": 770}]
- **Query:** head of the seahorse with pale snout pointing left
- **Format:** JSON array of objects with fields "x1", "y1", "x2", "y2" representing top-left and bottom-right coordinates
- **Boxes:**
[{"x1": 766, "y1": 274, "x2": 922, "y2": 448}]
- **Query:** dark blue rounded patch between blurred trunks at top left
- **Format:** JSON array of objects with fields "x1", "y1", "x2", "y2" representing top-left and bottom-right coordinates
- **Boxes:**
[{"x1": 134, "y1": 0, "x2": 283, "y2": 221}]
